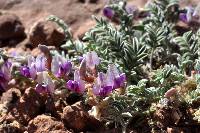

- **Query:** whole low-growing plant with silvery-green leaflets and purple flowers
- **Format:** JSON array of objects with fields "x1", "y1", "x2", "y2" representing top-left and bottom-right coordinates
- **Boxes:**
[{"x1": 0, "y1": 0, "x2": 200, "y2": 132}]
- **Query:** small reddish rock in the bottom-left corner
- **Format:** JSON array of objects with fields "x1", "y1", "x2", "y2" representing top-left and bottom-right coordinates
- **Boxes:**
[{"x1": 0, "y1": 121, "x2": 25, "y2": 133}]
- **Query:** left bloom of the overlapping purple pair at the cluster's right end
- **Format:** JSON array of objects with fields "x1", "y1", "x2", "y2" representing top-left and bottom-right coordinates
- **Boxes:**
[{"x1": 93, "y1": 72, "x2": 113, "y2": 97}]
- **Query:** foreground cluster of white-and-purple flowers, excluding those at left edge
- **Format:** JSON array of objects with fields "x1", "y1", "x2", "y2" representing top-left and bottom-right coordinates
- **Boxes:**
[{"x1": 20, "y1": 51, "x2": 126, "y2": 96}]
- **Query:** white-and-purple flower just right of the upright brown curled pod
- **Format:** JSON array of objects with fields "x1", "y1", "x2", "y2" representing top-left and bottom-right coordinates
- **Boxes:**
[{"x1": 51, "y1": 55, "x2": 72, "y2": 77}]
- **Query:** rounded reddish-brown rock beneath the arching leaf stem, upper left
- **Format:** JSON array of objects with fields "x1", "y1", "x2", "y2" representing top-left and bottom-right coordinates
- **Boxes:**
[{"x1": 29, "y1": 20, "x2": 65, "y2": 47}]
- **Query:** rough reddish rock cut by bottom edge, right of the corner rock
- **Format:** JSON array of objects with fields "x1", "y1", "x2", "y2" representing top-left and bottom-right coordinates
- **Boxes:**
[{"x1": 27, "y1": 115, "x2": 70, "y2": 133}]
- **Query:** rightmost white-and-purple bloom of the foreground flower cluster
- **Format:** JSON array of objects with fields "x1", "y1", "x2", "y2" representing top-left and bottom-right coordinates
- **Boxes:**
[{"x1": 107, "y1": 64, "x2": 126, "y2": 89}]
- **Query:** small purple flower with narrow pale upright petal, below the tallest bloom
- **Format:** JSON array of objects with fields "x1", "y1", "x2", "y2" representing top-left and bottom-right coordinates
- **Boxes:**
[{"x1": 66, "y1": 70, "x2": 85, "y2": 93}]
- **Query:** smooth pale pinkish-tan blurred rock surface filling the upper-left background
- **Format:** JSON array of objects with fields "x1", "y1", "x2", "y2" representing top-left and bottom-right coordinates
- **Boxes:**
[{"x1": 0, "y1": 0, "x2": 105, "y2": 38}]
